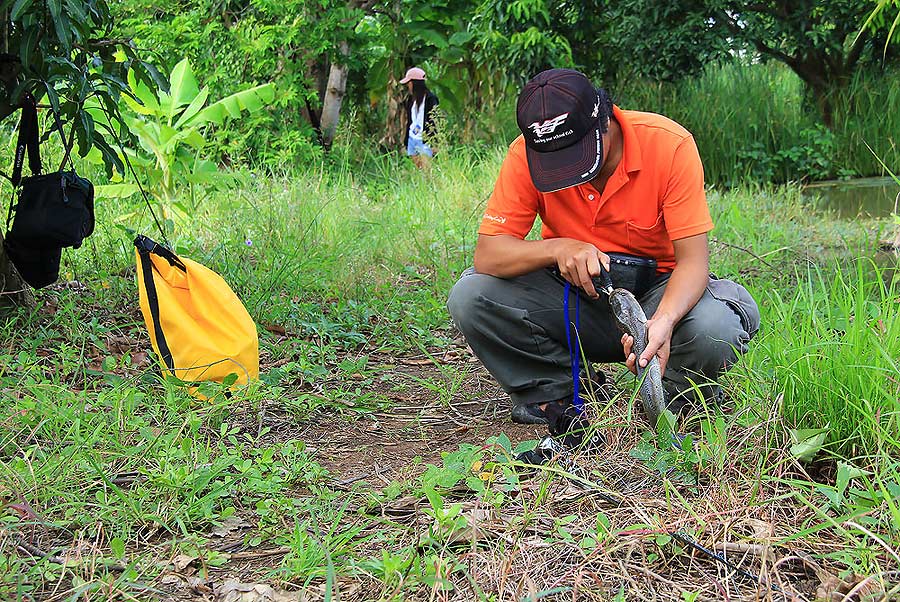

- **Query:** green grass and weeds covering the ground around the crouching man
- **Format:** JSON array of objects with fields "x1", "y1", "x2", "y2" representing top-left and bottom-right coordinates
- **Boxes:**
[{"x1": 0, "y1": 149, "x2": 900, "y2": 600}]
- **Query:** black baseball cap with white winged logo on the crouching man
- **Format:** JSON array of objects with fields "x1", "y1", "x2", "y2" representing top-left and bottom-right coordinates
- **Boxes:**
[{"x1": 516, "y1": 69, "x2": 606, "y2": 192}]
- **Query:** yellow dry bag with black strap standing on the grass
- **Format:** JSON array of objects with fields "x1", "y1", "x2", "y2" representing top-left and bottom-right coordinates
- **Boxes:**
[{"x1": 134, "y1": 236, "x2": 259, "y2": 385}]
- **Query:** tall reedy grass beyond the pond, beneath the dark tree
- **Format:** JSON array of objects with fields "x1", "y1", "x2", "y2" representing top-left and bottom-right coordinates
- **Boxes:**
[{"x1": 614, "y1": 62, "x2": 900, "y2": 185}]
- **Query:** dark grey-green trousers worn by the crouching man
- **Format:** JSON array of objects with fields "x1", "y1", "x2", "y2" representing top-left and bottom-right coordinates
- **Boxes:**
[{"x1": 447, "y1": 269, "x2": 759, "y2": 409}]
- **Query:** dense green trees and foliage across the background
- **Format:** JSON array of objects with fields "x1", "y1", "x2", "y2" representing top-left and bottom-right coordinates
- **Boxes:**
[{"x1": 102, "y1": 0, "x2": 900, "y2": 184}]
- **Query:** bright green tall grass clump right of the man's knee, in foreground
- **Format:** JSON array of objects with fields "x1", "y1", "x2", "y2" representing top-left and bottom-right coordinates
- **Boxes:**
[{"x1": 747, "y1": 259, "x2": 900, "y2": 458}]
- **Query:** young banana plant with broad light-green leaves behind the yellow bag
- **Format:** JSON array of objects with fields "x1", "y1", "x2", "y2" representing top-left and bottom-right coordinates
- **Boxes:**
[{"x1": 88, "y1": 59, "x2": 275, "y2": 224}]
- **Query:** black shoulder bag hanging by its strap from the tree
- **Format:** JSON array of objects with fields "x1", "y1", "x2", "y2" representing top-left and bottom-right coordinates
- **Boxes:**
[{"x1": 5, "y1": 94, "x2": 94, "y2": 288}]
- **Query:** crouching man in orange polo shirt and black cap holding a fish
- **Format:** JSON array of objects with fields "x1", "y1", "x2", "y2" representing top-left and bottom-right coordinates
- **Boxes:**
[{"x1": 447, "y1": 69, "x2": 759, "y2": 445}]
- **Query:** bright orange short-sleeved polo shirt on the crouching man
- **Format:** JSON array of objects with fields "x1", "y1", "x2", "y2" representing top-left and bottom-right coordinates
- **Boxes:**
[{"x1": 478, "y1": 107, "x2": 713, "y2": 272}]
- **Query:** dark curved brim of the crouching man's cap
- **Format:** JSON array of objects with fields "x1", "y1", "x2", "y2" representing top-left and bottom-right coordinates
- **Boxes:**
[{"x1": 525, "y1": 126, "x2": 603, "y2": 192}]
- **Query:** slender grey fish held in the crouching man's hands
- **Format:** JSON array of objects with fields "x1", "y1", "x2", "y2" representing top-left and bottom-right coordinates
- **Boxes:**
[{"x1": 608, "y1": 288, "x2": 666, "y2": 428}]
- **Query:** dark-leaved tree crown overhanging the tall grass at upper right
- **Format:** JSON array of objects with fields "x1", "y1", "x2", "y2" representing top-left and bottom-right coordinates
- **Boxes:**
[{"x1": 585, "y1": 0, "x2": 900, "y2": 127}]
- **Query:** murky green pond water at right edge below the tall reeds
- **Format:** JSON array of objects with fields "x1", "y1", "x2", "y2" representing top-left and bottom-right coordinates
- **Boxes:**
[{"x1": 803, "y1": 178, "x2": 900, "y2": 218}]
